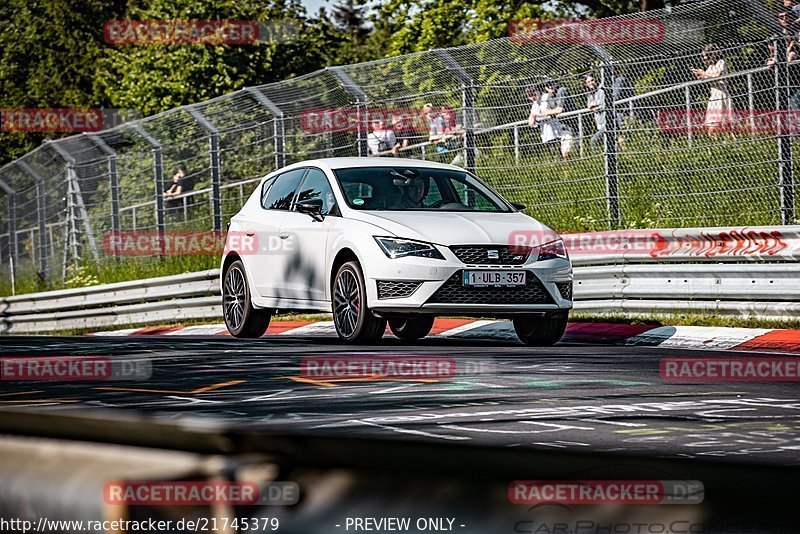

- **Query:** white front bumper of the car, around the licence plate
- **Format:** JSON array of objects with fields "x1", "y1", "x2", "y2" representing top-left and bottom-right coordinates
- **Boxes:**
[{"x1": 365, "y1": 246, "x2": 572, "y2": 317}]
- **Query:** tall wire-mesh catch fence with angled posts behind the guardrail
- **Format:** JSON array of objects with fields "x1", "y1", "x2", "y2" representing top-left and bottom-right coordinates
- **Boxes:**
[{"x1": 0, "y1": 0, "x2": 800, "y2": 294}]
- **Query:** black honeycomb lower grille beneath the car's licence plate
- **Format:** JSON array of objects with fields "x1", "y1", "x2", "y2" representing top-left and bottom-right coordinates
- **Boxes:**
[{"x1": 426, "y1": 271, "x2": 553, "y2": 304}]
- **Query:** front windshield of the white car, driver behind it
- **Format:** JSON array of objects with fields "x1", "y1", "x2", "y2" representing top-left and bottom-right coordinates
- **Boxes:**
[{"x1": 334, "y1": 167, "x2": 511, "y2": 212}]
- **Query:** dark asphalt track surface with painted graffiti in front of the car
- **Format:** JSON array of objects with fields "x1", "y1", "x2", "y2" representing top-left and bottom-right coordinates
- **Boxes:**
[{"x1": 0, "y1": 336, "x2": 800, "y2": 466}]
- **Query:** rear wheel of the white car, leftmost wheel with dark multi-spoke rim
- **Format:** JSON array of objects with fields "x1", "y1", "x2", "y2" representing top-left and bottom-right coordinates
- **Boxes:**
[{"x1": 222, "y1": 260, "x2": 272, "y2": 338}]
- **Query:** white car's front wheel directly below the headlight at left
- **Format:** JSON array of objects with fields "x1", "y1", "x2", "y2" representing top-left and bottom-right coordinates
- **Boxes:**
[{"x1": 331, "y1": 261, "x2": 386, "y2": 343}]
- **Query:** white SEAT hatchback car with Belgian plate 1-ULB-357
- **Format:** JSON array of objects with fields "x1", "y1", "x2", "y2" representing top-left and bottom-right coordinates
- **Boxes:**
[{"x1": 221, "y1": 158, "x2": 572, "y2": 345}]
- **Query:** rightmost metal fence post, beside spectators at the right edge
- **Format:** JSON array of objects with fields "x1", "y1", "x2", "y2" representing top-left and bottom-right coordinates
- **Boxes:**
[{"x1": 773, "y1": 37, "x2": 795, "y2": 224}]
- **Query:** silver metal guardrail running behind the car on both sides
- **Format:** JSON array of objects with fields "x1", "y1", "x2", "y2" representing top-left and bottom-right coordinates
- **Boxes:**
[{"x1": 0, "y1": 226, "x2": 800, "y2": 334}]
